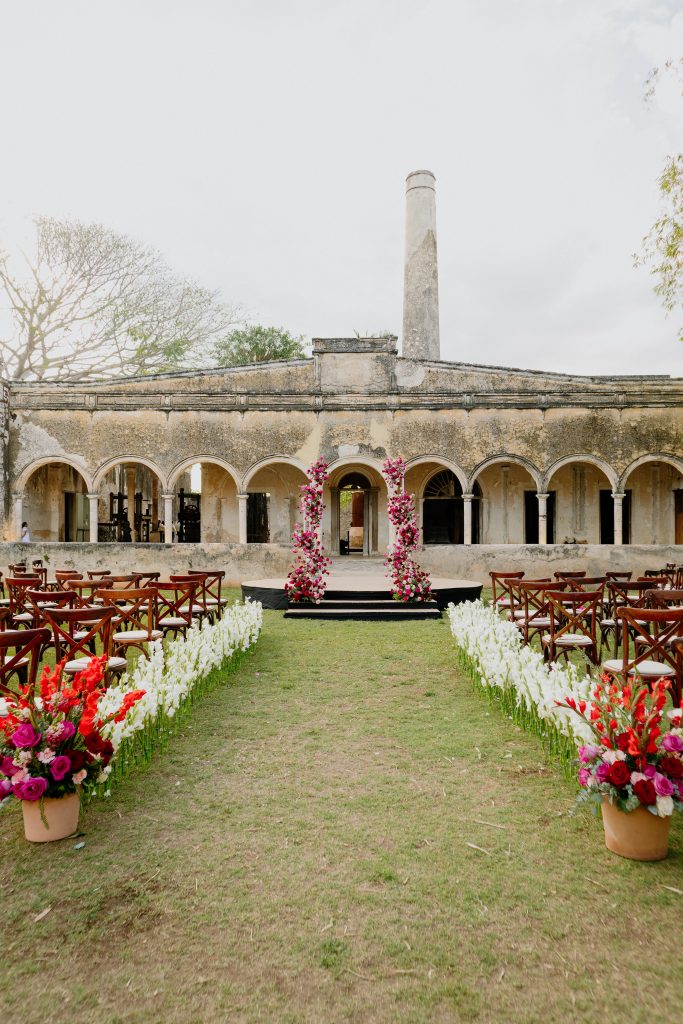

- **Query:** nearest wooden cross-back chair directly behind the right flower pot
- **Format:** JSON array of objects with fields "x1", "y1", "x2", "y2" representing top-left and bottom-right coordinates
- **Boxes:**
[{"x1": 602, "y1": 606, "x2": 683, "y2": 707}]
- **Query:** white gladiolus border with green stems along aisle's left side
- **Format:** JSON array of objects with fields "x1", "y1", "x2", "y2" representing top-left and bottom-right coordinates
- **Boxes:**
[{"x1": 89, "y1": 600, "x2": 263, "y2": 796}]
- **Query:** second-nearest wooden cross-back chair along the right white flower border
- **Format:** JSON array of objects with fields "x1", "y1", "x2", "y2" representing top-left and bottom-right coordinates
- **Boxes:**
[{"x1": 541, "y1": 590, "x2": 602, "y2": 665}]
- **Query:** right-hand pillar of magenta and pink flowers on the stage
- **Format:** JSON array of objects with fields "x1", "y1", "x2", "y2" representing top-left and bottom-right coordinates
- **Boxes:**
[{"x1": 382, "y1": 457, "x2": 431, "y2": 601}]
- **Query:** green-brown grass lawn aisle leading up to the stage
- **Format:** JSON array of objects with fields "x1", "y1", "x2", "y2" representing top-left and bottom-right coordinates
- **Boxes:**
[{"x1": 0, "y1": 612, "x2": 683, "y2": 1024}]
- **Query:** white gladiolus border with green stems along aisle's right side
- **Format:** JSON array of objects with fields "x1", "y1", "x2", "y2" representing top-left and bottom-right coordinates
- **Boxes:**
[{"x1": 447, "y1": 601, "x2": 594, "y2": 775}]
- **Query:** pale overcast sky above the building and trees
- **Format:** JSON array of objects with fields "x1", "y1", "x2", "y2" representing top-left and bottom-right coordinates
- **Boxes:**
[{"x1": 0, "y1": 0, "x2": 683, "y2": 375}]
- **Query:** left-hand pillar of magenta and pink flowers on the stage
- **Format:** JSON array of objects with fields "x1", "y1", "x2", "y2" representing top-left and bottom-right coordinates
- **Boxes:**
[{"x1": 285, "y1": 459, "x2": 331, "y2": 604}]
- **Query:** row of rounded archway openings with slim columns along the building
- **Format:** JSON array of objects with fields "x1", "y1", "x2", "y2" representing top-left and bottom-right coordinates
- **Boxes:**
[{"x1": 12, "y1": 453, "x2": 683, "y2": 554}]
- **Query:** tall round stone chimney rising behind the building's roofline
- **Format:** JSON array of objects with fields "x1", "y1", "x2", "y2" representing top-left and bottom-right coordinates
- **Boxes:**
[{"x1": 402, "y1": 171, "x2": 440, "y2": 359}]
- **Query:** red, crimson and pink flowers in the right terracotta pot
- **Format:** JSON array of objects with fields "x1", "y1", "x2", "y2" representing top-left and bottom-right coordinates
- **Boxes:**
[{"x1": 556, "y1": 675, "x2": 683, "y2": 818}]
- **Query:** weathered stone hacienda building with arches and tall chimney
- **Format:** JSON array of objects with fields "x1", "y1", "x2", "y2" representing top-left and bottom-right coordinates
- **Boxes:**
[{"x1": 1, "y1": 171, "x2": 683, "y2": 580}]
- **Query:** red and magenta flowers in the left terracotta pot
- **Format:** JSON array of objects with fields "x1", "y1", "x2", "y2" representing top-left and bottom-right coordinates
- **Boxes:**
[{"x1": 0, "y1": 656, "x2": 145, "y2": 801}]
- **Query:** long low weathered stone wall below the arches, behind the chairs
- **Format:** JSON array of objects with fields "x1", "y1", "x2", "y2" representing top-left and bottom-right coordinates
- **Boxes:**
[{"x1": 0, "y1": 543, "x2": 683, "y2": 585}]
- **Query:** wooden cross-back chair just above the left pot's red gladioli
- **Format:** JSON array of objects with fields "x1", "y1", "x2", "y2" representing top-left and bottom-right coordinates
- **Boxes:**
[{"x1": 43, "y1": 605, "x2": 128, "y2": 685}]
